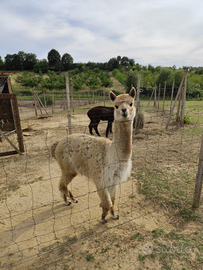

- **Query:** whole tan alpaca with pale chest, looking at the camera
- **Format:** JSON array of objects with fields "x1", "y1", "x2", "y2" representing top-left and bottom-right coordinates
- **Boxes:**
[{"x1": 51, "y1": 88, "x2": 136, "y2": 223}]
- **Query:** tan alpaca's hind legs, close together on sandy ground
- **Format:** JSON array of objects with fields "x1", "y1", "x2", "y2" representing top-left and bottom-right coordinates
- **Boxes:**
[{"x1": 59, "y1": 174, "x2": 78, "y2": 205}]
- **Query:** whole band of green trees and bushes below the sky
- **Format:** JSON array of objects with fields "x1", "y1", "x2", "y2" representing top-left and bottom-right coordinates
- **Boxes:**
[{"x1": 0, "y1": 49, "x2": 203, "y2": 97}]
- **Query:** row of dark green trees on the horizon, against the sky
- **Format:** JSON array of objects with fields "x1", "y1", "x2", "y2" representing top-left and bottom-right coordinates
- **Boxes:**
[{"x1": 0, "y1": 49, "x2": 135, "y2": 73}]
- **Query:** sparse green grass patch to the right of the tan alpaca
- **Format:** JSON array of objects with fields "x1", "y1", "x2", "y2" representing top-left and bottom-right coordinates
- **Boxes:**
[{"x1": 132, "y1": 101, "x2": 203, "y2": 222}]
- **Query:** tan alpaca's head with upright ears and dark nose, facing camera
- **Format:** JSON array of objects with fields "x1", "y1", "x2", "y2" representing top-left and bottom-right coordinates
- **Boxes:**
[{"x1": 109, "y1": 87, "x2": 136, "y2": 121}]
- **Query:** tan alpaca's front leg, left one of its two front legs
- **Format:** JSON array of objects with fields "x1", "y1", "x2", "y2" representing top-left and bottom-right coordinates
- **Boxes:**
[{"x1": 98, "y1": 189, "x2": 112, "y2": 224}]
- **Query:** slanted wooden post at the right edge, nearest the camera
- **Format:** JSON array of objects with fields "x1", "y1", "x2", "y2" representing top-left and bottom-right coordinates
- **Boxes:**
[{"x1": 192, "y1": 134, "x2": 203, "y2": 209}]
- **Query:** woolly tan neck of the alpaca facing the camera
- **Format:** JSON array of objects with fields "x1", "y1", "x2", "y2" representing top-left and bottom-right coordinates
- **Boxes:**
[{"x1": 112, "y1": 121, "x2": 132, "y2": 161}]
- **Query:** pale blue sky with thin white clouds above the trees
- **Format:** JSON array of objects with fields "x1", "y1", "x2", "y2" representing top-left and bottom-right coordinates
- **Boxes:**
[{"x1": 0, "y1": 0, "x2": 203, "y2": 68}]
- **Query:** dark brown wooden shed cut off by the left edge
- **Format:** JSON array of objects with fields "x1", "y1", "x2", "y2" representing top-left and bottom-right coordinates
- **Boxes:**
[{"x1": 0, "y1": 71, "x2": 25, "y2": 156}]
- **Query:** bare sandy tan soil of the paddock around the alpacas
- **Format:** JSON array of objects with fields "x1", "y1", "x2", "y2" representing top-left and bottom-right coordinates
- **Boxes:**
[{"x1": 0, "y1": 101, "x2": 202, "y2": 270}]
